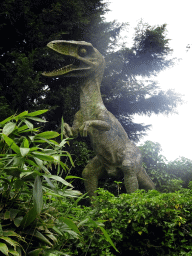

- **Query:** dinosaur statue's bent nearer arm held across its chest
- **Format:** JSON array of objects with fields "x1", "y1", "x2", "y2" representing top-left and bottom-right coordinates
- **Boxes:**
[{"x1": 79, "y1": 120, "x2": 111, "y2": 137}]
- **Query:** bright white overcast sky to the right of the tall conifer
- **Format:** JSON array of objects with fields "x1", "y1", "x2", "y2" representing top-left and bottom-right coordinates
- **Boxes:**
[{"x1": 104, "y1": 0, "x2": 192, "y2": 161}]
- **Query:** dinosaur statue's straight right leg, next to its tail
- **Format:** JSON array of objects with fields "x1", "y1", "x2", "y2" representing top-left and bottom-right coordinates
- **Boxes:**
[{"x1": 121, "y1": 160, "x2": 139, "y2": 193}]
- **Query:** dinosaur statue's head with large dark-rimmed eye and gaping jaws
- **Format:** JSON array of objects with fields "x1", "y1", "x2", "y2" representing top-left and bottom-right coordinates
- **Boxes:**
[{"x1": 42, "y1": 40, "x2": 105, "y2": 77}]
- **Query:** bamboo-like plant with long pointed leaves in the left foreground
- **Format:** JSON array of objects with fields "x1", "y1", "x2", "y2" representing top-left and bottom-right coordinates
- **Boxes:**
[{"x1": 0, "y1": 110, "x2": 116, "y2": 256}]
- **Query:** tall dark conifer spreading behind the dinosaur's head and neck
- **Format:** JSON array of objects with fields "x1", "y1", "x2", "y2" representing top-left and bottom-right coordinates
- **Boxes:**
[{"x1": 0, "y1": 0, "x2": 180, "y2": 139}]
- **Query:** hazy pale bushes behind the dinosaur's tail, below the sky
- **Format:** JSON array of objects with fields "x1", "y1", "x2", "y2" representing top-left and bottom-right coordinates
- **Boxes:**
[{"x1": 140, "y1": 141, "x2": 192, "y2": 192}]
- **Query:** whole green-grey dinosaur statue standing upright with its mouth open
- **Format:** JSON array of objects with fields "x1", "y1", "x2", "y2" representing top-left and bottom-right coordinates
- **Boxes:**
[{"x1": 43, "y1": 40, "x2": 155, "y2": 197}]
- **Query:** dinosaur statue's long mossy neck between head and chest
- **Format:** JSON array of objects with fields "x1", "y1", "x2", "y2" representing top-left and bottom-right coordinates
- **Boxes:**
[{"x1": 80, "y1": 68, "x2": 105, "y2": 116}]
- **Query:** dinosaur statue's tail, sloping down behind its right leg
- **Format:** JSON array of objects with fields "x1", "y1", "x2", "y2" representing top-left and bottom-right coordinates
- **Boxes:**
[{"x1": 137, "y1": 167, "x2": 155, "y2": 190}]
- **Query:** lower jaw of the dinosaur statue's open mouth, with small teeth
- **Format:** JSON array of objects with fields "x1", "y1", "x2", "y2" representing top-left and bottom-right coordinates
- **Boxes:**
[{"x1": 42, "y1": 58, "x2": 91, "y2": 76}]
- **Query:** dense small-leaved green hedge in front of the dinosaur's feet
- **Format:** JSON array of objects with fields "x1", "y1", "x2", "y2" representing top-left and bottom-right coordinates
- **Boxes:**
[{"x1": 70, "y1": 189, "x2": 192, "y2": 256}]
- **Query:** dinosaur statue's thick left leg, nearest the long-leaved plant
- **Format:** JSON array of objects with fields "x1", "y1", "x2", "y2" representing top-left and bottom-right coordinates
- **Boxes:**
[{"x1": 82, "y1": 156, "x2": 104, "y2": 197}]
